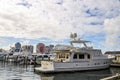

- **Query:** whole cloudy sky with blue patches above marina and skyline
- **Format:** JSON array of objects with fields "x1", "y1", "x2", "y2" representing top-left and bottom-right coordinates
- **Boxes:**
[{"x1": 0, "y1": 0, "x2": 120, "y2": 51}]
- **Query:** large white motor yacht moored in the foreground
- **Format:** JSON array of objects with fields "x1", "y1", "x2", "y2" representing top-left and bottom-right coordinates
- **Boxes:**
[{"x1": 35, "y1": 33, "x2": 111, "y2": 73}]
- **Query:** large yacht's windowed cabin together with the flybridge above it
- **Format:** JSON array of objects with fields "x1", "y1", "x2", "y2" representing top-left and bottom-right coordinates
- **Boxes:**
[{"x1": 54, "y1": 39, "x2": 93, "y2": 62}]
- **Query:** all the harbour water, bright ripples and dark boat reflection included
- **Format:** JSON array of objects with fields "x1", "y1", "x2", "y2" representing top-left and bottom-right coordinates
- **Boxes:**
[{"x1": 0, "y1": 62, "x2": 120, "y2": 80}]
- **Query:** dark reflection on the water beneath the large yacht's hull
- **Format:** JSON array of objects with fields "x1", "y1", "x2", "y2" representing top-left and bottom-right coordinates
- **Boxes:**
[{"x1": 37, "y1": 69, "x2": 112, "y2": 80}]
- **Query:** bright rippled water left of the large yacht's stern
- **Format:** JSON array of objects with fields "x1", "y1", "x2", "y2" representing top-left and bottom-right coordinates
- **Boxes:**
[{"x1": 0, "y1": 62, "x2": 40, "y2": 80}]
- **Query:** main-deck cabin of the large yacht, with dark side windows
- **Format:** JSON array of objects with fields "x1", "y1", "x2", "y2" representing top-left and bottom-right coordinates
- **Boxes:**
[{"x1": 54, "y1": 50, "x2": 91, "y2": 62}]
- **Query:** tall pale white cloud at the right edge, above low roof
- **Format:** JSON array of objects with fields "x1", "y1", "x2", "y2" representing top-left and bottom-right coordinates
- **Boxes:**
[{"x1": 104, "y1": 16, "x2": 120, "y2": 50}]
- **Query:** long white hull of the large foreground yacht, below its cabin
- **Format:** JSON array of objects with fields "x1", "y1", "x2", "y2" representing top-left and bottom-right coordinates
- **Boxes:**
[{"x1": 35, "y1": 60, "x2": 110, "y2": 73}]
